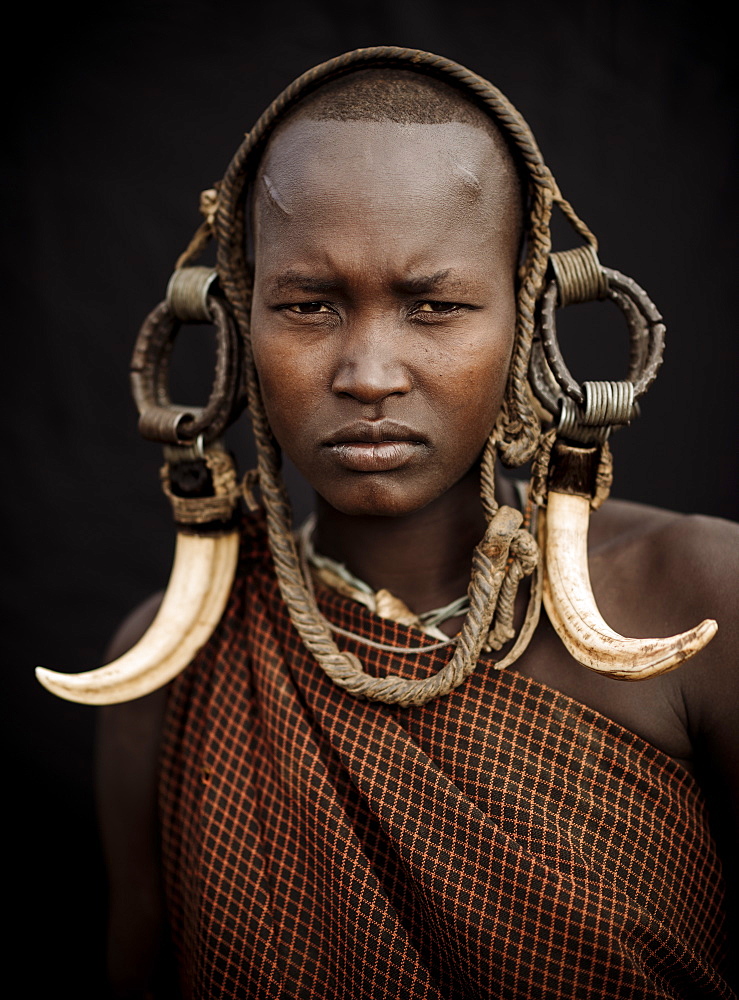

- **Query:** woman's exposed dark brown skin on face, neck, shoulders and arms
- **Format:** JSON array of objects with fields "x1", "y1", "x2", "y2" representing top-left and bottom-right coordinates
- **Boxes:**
[{"x1": 98, "y1": 120, "x2": 739, "y2": 997}]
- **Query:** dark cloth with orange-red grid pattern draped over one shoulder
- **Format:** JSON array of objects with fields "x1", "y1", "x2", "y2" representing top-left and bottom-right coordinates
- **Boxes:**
[{"x1": 160, "y1": 519, "x2": 732, "y2": 1000}]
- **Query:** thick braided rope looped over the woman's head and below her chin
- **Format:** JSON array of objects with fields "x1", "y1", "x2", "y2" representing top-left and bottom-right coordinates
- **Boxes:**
[{"x1": 188, "y1": 46, "x2": 597, "y2": 705}]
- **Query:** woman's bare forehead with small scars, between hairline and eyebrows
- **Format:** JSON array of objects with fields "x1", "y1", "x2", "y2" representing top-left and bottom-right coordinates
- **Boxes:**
[{"x1": 254, "y1": 119, "x2": 518, "y2": 249}]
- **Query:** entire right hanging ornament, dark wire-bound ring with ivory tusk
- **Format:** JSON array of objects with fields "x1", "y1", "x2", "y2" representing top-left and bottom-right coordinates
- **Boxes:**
[{"x1": 530, "y1": 246, "x2": 718, "y2": 680}]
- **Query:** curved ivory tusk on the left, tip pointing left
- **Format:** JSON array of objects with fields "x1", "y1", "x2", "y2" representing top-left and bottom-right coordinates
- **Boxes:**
[{"x1": 36, "y1": 531, "x2": 239, "y2": 705}]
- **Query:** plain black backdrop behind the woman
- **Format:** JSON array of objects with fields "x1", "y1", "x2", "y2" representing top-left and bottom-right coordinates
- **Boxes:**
[{"x1": 2, "y1": 0, "x2": 739, "y2": 997}]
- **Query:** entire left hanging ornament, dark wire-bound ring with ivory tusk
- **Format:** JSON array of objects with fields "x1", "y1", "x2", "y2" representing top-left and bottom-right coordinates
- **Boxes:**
[{"x1": 36, "y1": 262, "x2": 246, "y2": 705}]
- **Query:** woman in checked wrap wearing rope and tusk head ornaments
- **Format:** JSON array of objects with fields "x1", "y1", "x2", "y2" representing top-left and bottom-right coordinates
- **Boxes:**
[{"x1": 45, "y1": 49, "x2": 739, "y2": 997}]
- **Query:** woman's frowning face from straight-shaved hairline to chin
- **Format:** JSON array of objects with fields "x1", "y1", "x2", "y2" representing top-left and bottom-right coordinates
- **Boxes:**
[{"x1": 252, "y1": 120, "x2": 518, "y2": 516}]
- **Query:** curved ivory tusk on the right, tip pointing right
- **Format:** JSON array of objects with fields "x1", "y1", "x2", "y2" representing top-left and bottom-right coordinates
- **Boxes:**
[{"x1": 540, "y1": 489, "x2": 718, "y2": 680}]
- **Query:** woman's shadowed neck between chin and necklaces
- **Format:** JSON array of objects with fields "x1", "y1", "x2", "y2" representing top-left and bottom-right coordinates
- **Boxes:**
[{"x1": 315, "y1": 468, "x2": 515, "y2": 614}]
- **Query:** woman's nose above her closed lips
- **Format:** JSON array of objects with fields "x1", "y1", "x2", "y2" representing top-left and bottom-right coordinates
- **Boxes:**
[{"x1": 331, "y1": 319, "x2": 411, "y2": 403}]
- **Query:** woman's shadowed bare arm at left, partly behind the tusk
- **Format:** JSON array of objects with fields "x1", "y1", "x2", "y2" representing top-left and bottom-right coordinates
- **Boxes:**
[{"x1": 96, "y1": 595, "x2": 177, "y2": 998}]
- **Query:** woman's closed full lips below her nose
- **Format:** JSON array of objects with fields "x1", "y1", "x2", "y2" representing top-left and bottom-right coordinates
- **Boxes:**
[{"x1": 324, "y1": 420, "x2": 428, "y2": 472}]
